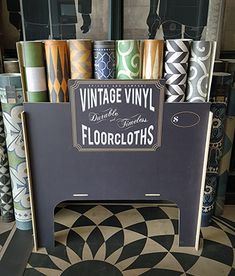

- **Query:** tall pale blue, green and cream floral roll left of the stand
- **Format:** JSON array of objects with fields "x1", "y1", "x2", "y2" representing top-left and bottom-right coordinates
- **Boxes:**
[{"x1": 0, "y1": 74, "x2": 31, "y2": 230}]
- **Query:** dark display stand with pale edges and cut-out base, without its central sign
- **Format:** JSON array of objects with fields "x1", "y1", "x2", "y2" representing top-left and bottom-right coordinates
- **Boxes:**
[{"x1": 22, "y1": 80, "x2": 212, "y2": 249}]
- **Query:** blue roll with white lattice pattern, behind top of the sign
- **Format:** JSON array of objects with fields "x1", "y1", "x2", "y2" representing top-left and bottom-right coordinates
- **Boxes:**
[{"x1": 93, "y1": 40, "x2": 116, "y2": 80}]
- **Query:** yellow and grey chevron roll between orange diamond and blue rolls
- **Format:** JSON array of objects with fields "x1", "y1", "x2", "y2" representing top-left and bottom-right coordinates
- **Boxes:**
[{"x1": 69, "y1": 39, "x2": 93, "y2": 79}]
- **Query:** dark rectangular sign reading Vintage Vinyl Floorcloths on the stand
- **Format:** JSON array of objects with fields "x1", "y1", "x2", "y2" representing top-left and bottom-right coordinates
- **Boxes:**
[{"x1": 69, "y1": 80, "x2": 165, "y2": 151}]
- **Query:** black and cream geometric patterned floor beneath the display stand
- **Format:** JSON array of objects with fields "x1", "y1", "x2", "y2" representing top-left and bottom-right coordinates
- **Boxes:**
[{"x1": 0, "y1": 204, "x2": 235, "y2": 276}]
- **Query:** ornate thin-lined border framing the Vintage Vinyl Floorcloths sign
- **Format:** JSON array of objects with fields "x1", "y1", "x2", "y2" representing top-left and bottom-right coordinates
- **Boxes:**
[{"x1": 69, "y1": 79, "x2": 165, "y2": 152}]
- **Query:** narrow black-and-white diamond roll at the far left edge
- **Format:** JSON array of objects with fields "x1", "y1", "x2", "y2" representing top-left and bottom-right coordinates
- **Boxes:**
[{"x1": 0, "y1": 104, "x2": 15, "y2": 222}]
